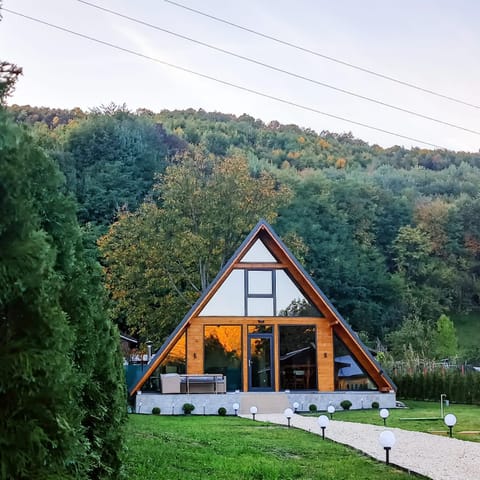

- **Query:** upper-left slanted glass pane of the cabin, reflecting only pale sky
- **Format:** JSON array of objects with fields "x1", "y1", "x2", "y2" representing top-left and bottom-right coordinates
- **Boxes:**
[{"x1": 200, "y1": 270, "x2": 245, "y2": 317}]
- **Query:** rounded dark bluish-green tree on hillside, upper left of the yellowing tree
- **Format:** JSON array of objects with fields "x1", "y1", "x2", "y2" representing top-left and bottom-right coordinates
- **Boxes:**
[{"x1": 60, "y1": 110, "x2": 175, "y2": 225}]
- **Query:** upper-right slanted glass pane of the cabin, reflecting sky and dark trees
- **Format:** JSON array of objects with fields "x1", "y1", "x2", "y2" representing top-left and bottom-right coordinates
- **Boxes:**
[{"x1": 276, "y1": 270, "x2": 323, "y2": 317}]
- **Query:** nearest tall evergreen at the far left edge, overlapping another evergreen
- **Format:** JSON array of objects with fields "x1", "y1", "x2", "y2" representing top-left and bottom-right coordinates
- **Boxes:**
[{"x1": 0, "y1": 111, "x2": 87, "y2": 479}]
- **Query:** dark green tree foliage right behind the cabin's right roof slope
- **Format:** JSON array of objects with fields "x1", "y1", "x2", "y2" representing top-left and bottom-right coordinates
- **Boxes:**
[{"x1": 278, "y1": 173, "x2": 401, "y2": 335}]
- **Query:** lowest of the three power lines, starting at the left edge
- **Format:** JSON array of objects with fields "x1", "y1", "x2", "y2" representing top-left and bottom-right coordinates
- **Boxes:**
[{"x1": 2, "y1": 7, "x2": 448, "y2": 150}]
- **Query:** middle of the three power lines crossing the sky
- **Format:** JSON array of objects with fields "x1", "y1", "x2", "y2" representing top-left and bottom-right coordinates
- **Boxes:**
[{"x1": 77, "y1": 0, "x2": 480, "y2": 135}]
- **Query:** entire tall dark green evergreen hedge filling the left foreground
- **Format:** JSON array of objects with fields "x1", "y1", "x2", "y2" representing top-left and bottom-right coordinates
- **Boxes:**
[{"x1": 0, "y1": 110, "x2": 125, "y2": 480}]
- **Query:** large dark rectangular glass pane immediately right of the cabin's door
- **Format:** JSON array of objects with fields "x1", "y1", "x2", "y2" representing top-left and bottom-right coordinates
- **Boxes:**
[{"x1": 279, "y1": 325, "x2": 317, "y2": 390}]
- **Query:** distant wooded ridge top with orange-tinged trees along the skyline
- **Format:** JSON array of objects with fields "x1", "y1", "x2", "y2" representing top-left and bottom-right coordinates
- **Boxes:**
[{"x1": 9, "y1": 105, "x2": 480, "y2": 170}]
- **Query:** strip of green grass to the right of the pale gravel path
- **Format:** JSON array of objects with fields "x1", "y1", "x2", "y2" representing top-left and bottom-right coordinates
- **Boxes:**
[{"x1": 312, "y1": 399, "x2": 480, "y2": 442}]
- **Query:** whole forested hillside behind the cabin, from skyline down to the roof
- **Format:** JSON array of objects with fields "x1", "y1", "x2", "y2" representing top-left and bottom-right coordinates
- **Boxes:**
[{"x1": 9, "y1": 105, "x2": 480, "y2": 358}]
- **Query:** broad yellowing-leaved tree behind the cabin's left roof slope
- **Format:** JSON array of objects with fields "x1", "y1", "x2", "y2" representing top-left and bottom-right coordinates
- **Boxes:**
[{"x1": 99, "y1": 151, "x2": 290, "y2": 341}]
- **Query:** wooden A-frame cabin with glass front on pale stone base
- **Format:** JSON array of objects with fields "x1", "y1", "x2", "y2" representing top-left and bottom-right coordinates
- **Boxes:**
[{"x1": 130, "y1": 221, "x2": 395, "y2": 413}]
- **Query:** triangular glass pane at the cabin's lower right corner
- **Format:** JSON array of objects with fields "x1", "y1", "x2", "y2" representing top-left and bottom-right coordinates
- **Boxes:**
[{"x1": 333, "y1": 335, "x2": 378, "y2": 390}]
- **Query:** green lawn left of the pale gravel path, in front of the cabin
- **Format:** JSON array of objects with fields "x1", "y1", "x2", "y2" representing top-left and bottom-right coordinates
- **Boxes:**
[{"x1": 125, "y1": 415, "x2": 424, "y2": 480}]
